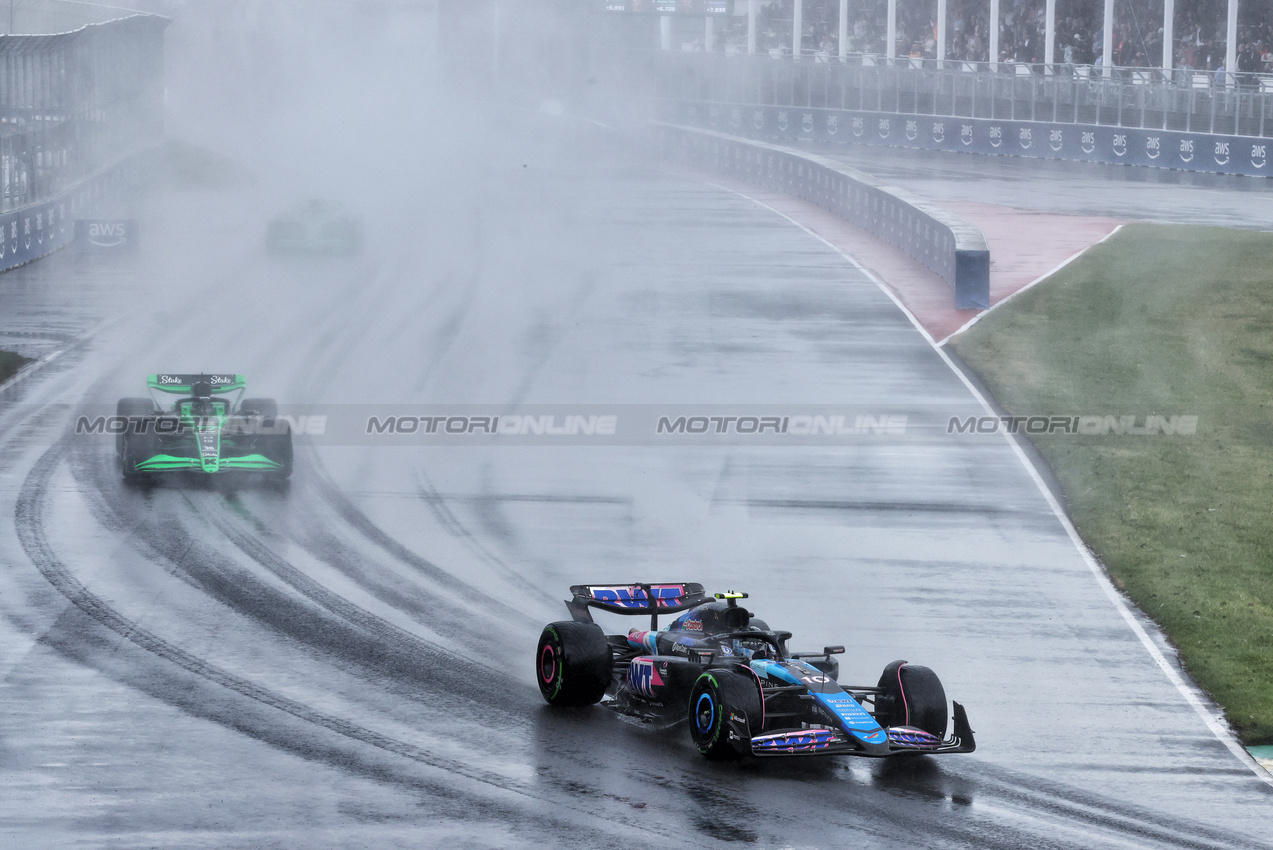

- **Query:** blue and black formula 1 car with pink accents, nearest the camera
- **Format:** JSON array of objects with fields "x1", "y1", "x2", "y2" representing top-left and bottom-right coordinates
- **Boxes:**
[{"x1": 535, "y1": 584, "x2": 976, "y2": 760}]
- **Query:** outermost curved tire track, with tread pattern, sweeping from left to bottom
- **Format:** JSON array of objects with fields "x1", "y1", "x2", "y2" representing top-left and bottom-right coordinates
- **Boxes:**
[{"x1": 14, "y1": 438, "x2": 670, "y2": 837}]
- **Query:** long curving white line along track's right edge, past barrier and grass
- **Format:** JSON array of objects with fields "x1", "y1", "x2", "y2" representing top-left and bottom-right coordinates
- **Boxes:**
[{"x1": 704, "y1": 181, "x2": 1273, "y2": 786}]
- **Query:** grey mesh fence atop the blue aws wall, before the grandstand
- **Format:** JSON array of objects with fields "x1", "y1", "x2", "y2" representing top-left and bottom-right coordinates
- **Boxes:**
[{"x1": 647, "y1": 52, "x2": 1273, "y2": 137}]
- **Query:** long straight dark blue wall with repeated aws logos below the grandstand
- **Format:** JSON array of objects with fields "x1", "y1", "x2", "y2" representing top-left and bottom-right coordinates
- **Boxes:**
[{"x1": 663, "y1": 102, "x2": 1273, "y2": 177}]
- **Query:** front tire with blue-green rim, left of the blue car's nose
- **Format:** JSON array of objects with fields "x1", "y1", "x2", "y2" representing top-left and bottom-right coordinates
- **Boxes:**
[{"x1": 689, "y1": 669, "x2": 761, "y2": 761}]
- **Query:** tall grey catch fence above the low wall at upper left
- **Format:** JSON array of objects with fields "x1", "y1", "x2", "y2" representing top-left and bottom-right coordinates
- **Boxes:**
[{"x1": 0, "y1": 11, "x2": 169, "y2": 271}]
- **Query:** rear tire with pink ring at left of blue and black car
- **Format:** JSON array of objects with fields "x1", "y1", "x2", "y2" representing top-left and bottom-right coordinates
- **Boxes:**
[{"x1": 535, "y1": 620, "x2": 614, "y2": 706}]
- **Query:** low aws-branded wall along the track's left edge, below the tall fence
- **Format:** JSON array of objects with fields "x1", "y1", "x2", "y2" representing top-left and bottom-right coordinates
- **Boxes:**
[{"x1": 0, "y1": 157, "x2": 141, "y2": 271}]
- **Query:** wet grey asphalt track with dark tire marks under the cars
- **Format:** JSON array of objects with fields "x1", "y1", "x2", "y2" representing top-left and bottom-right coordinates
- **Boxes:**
[{"x1": 0, "y1": 117, "x2": 1273, "y2": 850}]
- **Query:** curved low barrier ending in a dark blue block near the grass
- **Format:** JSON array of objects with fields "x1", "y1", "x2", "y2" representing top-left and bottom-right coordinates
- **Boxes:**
[{"x1": 656, "y1": 123, "x2": 990, "y2": 309}]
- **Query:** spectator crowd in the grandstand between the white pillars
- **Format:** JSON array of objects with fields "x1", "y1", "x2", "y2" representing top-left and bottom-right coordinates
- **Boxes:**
[{"x1": 713, "y1": 0, "x2": 1273, "y2": 74}]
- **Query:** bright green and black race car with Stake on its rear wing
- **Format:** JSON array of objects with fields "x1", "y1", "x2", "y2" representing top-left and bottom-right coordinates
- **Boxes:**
[{"x1": 115, "y1": 373, "x2": 292, "y2": 481}]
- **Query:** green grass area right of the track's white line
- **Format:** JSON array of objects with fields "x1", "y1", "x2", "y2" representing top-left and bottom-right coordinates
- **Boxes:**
[{"x1": 955, "y1": 225, "x2": 1273, "y2": 746}]
